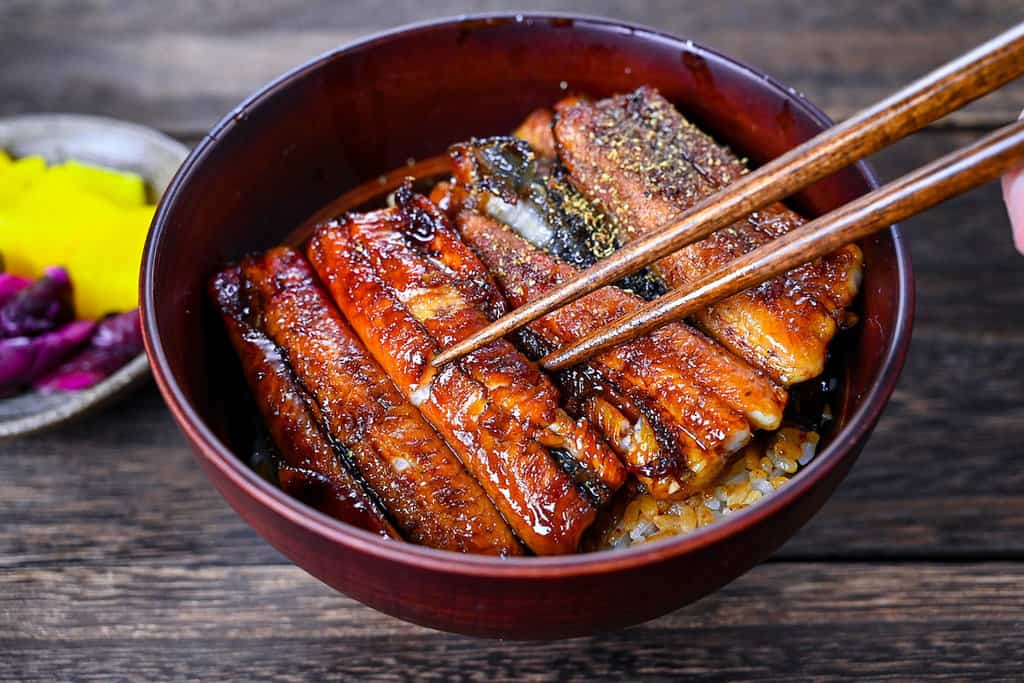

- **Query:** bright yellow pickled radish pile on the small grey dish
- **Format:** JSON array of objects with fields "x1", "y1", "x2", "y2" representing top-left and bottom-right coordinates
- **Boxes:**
[{"x1": 0, "y1": 153, "x2": 156, "y2": 318}]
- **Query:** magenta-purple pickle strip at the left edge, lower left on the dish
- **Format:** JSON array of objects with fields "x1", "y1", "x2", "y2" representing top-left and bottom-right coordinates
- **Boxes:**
[{"x1": 0, "y1": 321, "x2": 96, "y2": 394}]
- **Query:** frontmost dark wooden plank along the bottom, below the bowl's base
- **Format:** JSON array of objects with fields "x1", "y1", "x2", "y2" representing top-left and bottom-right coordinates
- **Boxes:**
[{"x1": 0, "y1": 563, "x2": 1024, "y2": 681}]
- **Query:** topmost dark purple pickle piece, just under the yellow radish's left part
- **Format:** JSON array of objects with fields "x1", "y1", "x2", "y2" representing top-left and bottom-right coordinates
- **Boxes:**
[{"x1": 0, "y1": 267, "x2": 75, "y2": 339}]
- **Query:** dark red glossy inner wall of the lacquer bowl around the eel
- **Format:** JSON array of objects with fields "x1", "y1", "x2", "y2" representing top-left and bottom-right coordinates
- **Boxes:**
[{"x1": 142, "y1": 16, "x2": 909, "y2": 561}]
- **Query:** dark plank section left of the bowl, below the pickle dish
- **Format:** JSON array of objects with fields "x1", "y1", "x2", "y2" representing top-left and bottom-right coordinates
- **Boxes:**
[{"x1": 0, "y1": 385, "x2": 285, "y2": 569}]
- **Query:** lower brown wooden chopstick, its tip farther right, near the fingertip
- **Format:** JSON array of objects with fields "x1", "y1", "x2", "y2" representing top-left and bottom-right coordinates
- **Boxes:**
[{"x1": 541, "y1": 121, "x2": 1024, "y2": 370}]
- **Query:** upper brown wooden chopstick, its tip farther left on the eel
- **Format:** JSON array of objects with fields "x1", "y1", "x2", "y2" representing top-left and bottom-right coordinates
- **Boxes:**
[{"x1": 431, "y1": 24, "x2": 1024, "y2": 367}]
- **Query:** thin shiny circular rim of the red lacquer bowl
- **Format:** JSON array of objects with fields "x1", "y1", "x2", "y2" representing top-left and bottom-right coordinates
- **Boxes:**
[{"x1": 139, "y1": 11, "x2": 914, "y2": 579}]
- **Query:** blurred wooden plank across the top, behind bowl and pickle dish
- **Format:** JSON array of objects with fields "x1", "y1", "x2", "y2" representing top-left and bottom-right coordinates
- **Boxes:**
[{"x1": 0, "y1": 0, "x2": 1024, "y2": 135}]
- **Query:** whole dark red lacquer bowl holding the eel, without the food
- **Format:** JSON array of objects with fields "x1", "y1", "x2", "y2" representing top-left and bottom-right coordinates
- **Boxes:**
[{"x1": 141, "y1": 15, "x2": 913, "y2": 638}]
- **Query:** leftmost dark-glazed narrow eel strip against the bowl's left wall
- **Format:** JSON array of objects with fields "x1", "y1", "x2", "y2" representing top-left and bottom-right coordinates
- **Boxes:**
[{"x1": 209, "y1": 266, "x2": 400, "y2": 539}]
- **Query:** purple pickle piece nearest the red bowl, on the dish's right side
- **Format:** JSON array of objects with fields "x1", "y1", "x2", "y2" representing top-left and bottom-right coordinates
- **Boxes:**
[{"x1": 35, "y1": 309, "x2": 142, "y2": 391}]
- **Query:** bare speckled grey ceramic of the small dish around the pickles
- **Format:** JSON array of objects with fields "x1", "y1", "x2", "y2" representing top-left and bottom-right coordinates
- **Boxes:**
[{"x1": 0, "y1": 114, "x2": 188, "y2": 438}]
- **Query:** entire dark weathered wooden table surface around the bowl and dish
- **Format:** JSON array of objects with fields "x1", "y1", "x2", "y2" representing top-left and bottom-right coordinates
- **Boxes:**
[{"x1": 0, "y1": 0, "x2": 1024, "y2": 681}]
